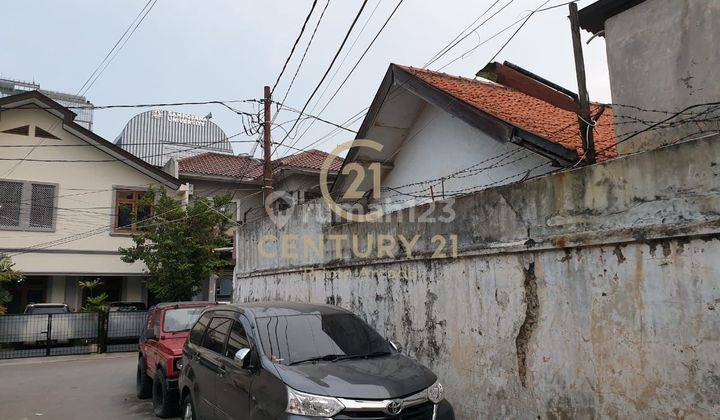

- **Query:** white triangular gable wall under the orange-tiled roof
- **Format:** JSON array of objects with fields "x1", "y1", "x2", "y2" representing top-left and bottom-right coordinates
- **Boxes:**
[{"x1": 381, "y1": 105, "x2": 553, "y2": 210}]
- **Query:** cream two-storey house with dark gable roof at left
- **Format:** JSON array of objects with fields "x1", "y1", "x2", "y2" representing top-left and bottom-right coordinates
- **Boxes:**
[{"x1": 0, "y1": 91, "x2": 181, "y2": 312}]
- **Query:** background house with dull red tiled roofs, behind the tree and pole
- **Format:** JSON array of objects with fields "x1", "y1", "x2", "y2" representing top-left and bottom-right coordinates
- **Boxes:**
[{"x1": 164, "y1": 149, "x2": 342, "y2": 301}]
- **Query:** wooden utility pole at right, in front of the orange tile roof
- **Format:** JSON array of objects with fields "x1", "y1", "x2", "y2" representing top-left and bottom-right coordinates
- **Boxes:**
[{"x1": 569, "y1": 2, "x2": 595, "y2": 164}]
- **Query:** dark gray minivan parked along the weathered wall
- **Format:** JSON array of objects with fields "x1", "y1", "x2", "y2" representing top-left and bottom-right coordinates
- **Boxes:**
[{"x1": 179, "y1": 302, "x2": 454, "y2": 420}]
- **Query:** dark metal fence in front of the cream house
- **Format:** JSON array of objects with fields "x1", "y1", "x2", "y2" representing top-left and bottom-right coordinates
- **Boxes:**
[{"x1": 0, "y1": 311, "x2": 147, "y2": 359}]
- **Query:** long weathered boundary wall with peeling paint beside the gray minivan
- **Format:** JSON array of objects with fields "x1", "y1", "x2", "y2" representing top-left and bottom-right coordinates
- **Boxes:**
[{"x1": 234, "y1": 138, "x2": 720, "y2": 419}]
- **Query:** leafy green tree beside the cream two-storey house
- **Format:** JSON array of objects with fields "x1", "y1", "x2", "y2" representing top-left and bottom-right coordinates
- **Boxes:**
[{"x1": 120, "y1": 189, "x2": 232, "y2": 302}]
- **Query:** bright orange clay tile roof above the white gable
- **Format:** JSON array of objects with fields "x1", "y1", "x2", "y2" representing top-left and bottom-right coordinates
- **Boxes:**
[{"x1": 399, "y1": 66, "x2": 617, "y2": 161}]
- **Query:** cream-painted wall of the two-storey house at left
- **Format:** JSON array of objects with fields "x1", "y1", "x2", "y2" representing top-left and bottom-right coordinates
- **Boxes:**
[{"x1": 0, "y1": 109, "x2": 180, "y2": 275}]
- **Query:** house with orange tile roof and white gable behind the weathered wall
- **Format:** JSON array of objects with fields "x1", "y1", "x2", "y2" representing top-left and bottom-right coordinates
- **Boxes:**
[{"x1": 331, "y1": 63, "x2": 615, "y2": 211}]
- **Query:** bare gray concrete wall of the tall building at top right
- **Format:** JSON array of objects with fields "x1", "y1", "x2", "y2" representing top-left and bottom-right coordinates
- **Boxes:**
[{"x1": 605, "y1": 0, "x2": 720, "y2": 154}]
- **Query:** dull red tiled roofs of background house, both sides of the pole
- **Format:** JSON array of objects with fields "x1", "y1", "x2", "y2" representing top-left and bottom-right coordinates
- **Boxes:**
[{"x1": 179, "y1": 149, "x2": 342, "y2": 179}]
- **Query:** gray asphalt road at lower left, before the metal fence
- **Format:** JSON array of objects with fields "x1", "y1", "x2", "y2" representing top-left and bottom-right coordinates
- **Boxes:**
[{"x1": 0, "y1": 353, "x2": 164, "y2": 420}]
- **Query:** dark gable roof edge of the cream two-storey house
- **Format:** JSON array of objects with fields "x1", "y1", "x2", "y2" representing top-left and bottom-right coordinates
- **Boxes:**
[{"x1": 0, "y1": 90, "x2": 181, "y2": 189}]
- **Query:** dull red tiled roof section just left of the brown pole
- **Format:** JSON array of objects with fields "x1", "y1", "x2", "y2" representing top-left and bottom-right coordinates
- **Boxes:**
[{"x1": 179, "y1": 152, "x2": 263, "y2": 179}]
